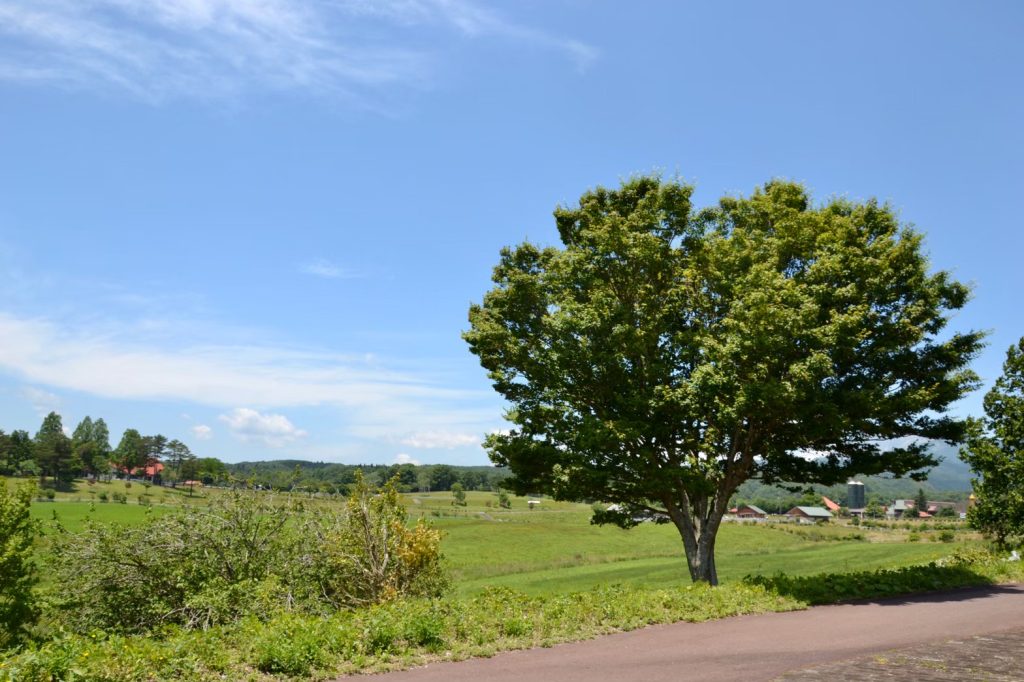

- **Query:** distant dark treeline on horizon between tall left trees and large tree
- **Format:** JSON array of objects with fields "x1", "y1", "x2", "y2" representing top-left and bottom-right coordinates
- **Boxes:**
[{"x1": 226, "y1": 460, "x2": 509, "y2": 493}]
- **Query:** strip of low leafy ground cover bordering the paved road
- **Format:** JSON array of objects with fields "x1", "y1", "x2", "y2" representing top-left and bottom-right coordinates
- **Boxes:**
[{"x1": 6, "y1": 550, "x2": 1024, "y2": 682}]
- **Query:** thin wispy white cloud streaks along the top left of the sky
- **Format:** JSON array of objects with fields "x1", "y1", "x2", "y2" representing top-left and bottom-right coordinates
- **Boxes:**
[{"x1": 0, "y1": 0, "x2": 594, "y2": 101}]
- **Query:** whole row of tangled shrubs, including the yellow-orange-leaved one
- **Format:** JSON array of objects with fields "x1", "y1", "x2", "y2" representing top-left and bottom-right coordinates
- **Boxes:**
[{"x1": 50, "y1": 473, "x2": 446, "y2": 633}]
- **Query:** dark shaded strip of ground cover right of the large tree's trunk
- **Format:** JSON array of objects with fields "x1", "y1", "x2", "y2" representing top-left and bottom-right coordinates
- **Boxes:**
[{"x1": 743, "y1": 562, "x2": 1020, "y2": 605}]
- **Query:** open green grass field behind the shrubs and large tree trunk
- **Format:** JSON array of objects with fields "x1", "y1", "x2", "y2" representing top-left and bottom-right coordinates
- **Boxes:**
[{"x1": 12, "y1": 481, "x2": 977, "y2": 595}]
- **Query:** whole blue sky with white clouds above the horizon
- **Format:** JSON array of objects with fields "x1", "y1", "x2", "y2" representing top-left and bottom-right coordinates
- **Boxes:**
[{"x1": 0, "y1": 0, "x2": 1024, "y2": 464}]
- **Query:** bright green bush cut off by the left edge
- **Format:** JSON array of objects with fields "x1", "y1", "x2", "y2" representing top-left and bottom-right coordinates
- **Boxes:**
[{"x1": 0, "y1": 479, "x2": 38, "y2": 650}]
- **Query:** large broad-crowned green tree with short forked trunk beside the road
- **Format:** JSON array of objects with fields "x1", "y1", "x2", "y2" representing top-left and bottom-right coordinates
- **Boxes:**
[{"x1": 465, "y1": 176, "x2": 982, "y2": 584}]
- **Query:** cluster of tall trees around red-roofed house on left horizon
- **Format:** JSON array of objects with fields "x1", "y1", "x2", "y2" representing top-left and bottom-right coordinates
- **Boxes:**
[{"x1": 0, "y1": 412, "x2": 222, "y2": 486}]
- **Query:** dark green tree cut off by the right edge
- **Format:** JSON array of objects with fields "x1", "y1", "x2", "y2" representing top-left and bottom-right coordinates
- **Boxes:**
[{"x1": 961, "y1": 338, "x2": 1024, "y2": 545}]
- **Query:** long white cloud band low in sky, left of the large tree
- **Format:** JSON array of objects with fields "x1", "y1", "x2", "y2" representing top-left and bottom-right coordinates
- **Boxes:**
[{"x1": 0, "y1": 312, "x2": 499, "y2": 442}]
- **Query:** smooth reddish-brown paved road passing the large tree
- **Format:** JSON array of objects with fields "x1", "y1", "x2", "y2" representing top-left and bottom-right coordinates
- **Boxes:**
[{"x1": 358, "y1": 586, "x2": 1024, "y2": 682}]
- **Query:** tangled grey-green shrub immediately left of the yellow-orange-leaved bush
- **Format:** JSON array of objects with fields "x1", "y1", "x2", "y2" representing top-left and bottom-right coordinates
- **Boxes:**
[{"x1": 53, "y1": 485, "x2": 295, "y2": 633}]
